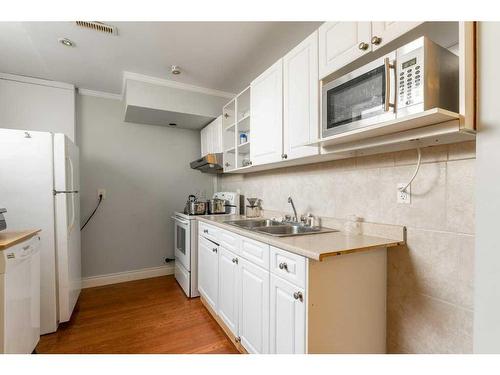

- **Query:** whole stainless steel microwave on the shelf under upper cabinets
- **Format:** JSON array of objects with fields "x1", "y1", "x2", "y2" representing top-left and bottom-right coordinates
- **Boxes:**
[{"x1": 322, "y1": 36, "x2": 458, "y2": 138}]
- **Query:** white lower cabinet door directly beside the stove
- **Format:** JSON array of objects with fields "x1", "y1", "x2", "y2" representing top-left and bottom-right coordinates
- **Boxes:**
[{"x1": 198, "y1": 236, "x2": 219, "y2": 311}]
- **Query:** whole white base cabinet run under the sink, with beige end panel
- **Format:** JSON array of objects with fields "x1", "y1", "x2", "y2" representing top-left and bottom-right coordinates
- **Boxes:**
[{"x1": 198, "y1": 223, "x2": 387, "y2": 354}]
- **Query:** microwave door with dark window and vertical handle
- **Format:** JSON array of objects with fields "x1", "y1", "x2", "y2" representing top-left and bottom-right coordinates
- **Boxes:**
[{"x1": 321, "y1": 53, "x2": 396, "y2": 138}]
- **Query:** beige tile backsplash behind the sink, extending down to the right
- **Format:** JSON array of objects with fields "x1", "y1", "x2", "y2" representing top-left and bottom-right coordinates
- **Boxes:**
[{"x1": 218, "y1": 142, "x2": 475, "y2": 353}]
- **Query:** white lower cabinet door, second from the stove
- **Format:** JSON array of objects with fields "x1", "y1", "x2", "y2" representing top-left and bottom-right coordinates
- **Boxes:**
[{"x1": 217, "y1": 247, "x2": 240, "y2": 336}]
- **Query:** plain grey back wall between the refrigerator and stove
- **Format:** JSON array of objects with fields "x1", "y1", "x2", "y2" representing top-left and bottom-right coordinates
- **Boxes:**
[{"x1": 77, "y1": 95, "x2": 213, "y2": 277}]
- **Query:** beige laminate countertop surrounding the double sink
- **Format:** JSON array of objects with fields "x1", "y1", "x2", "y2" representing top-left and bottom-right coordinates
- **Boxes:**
[{"x1": 196, "y1": 215, "x2": 404, "y2": 261}]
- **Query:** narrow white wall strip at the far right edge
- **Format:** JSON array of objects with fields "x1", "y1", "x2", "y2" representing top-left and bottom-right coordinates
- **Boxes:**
[{"x1": 474, "y1": 22, "x2": 500, "y2": 353}]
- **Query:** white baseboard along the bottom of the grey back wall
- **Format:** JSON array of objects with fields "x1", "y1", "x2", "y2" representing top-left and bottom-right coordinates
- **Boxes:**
[{"x1": 82, "y1": 263, "x2": 175, "y2": 289}]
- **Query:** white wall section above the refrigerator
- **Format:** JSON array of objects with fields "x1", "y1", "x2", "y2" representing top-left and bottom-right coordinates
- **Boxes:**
[{"x1": 0, "y1": 73, "x2": 75, "y2": 141}]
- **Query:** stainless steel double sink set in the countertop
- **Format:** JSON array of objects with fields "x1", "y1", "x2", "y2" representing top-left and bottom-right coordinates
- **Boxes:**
[{"x1": 224, "y1": 219, "x2": 338, "y2": 237}]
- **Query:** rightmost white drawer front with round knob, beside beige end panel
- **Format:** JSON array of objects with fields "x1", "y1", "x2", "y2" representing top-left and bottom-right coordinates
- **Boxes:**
[{"x1": 271, "y1": 246, "x2": 306, "y2": 288}]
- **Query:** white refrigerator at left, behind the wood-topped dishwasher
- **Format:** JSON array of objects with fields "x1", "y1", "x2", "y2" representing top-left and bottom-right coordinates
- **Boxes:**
[{"x1": 0, "y1": 128, "x2": 81, "y2": 334}]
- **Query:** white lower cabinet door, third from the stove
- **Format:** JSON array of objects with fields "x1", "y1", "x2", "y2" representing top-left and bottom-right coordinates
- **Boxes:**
[{"x1": 239, "y1": 259, "x2": 269, "y2": 354}]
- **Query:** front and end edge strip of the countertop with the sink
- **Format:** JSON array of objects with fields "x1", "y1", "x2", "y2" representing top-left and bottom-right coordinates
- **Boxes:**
[{"x1": 196, "y1": 216, "x2": 404, "y2": 261}]
